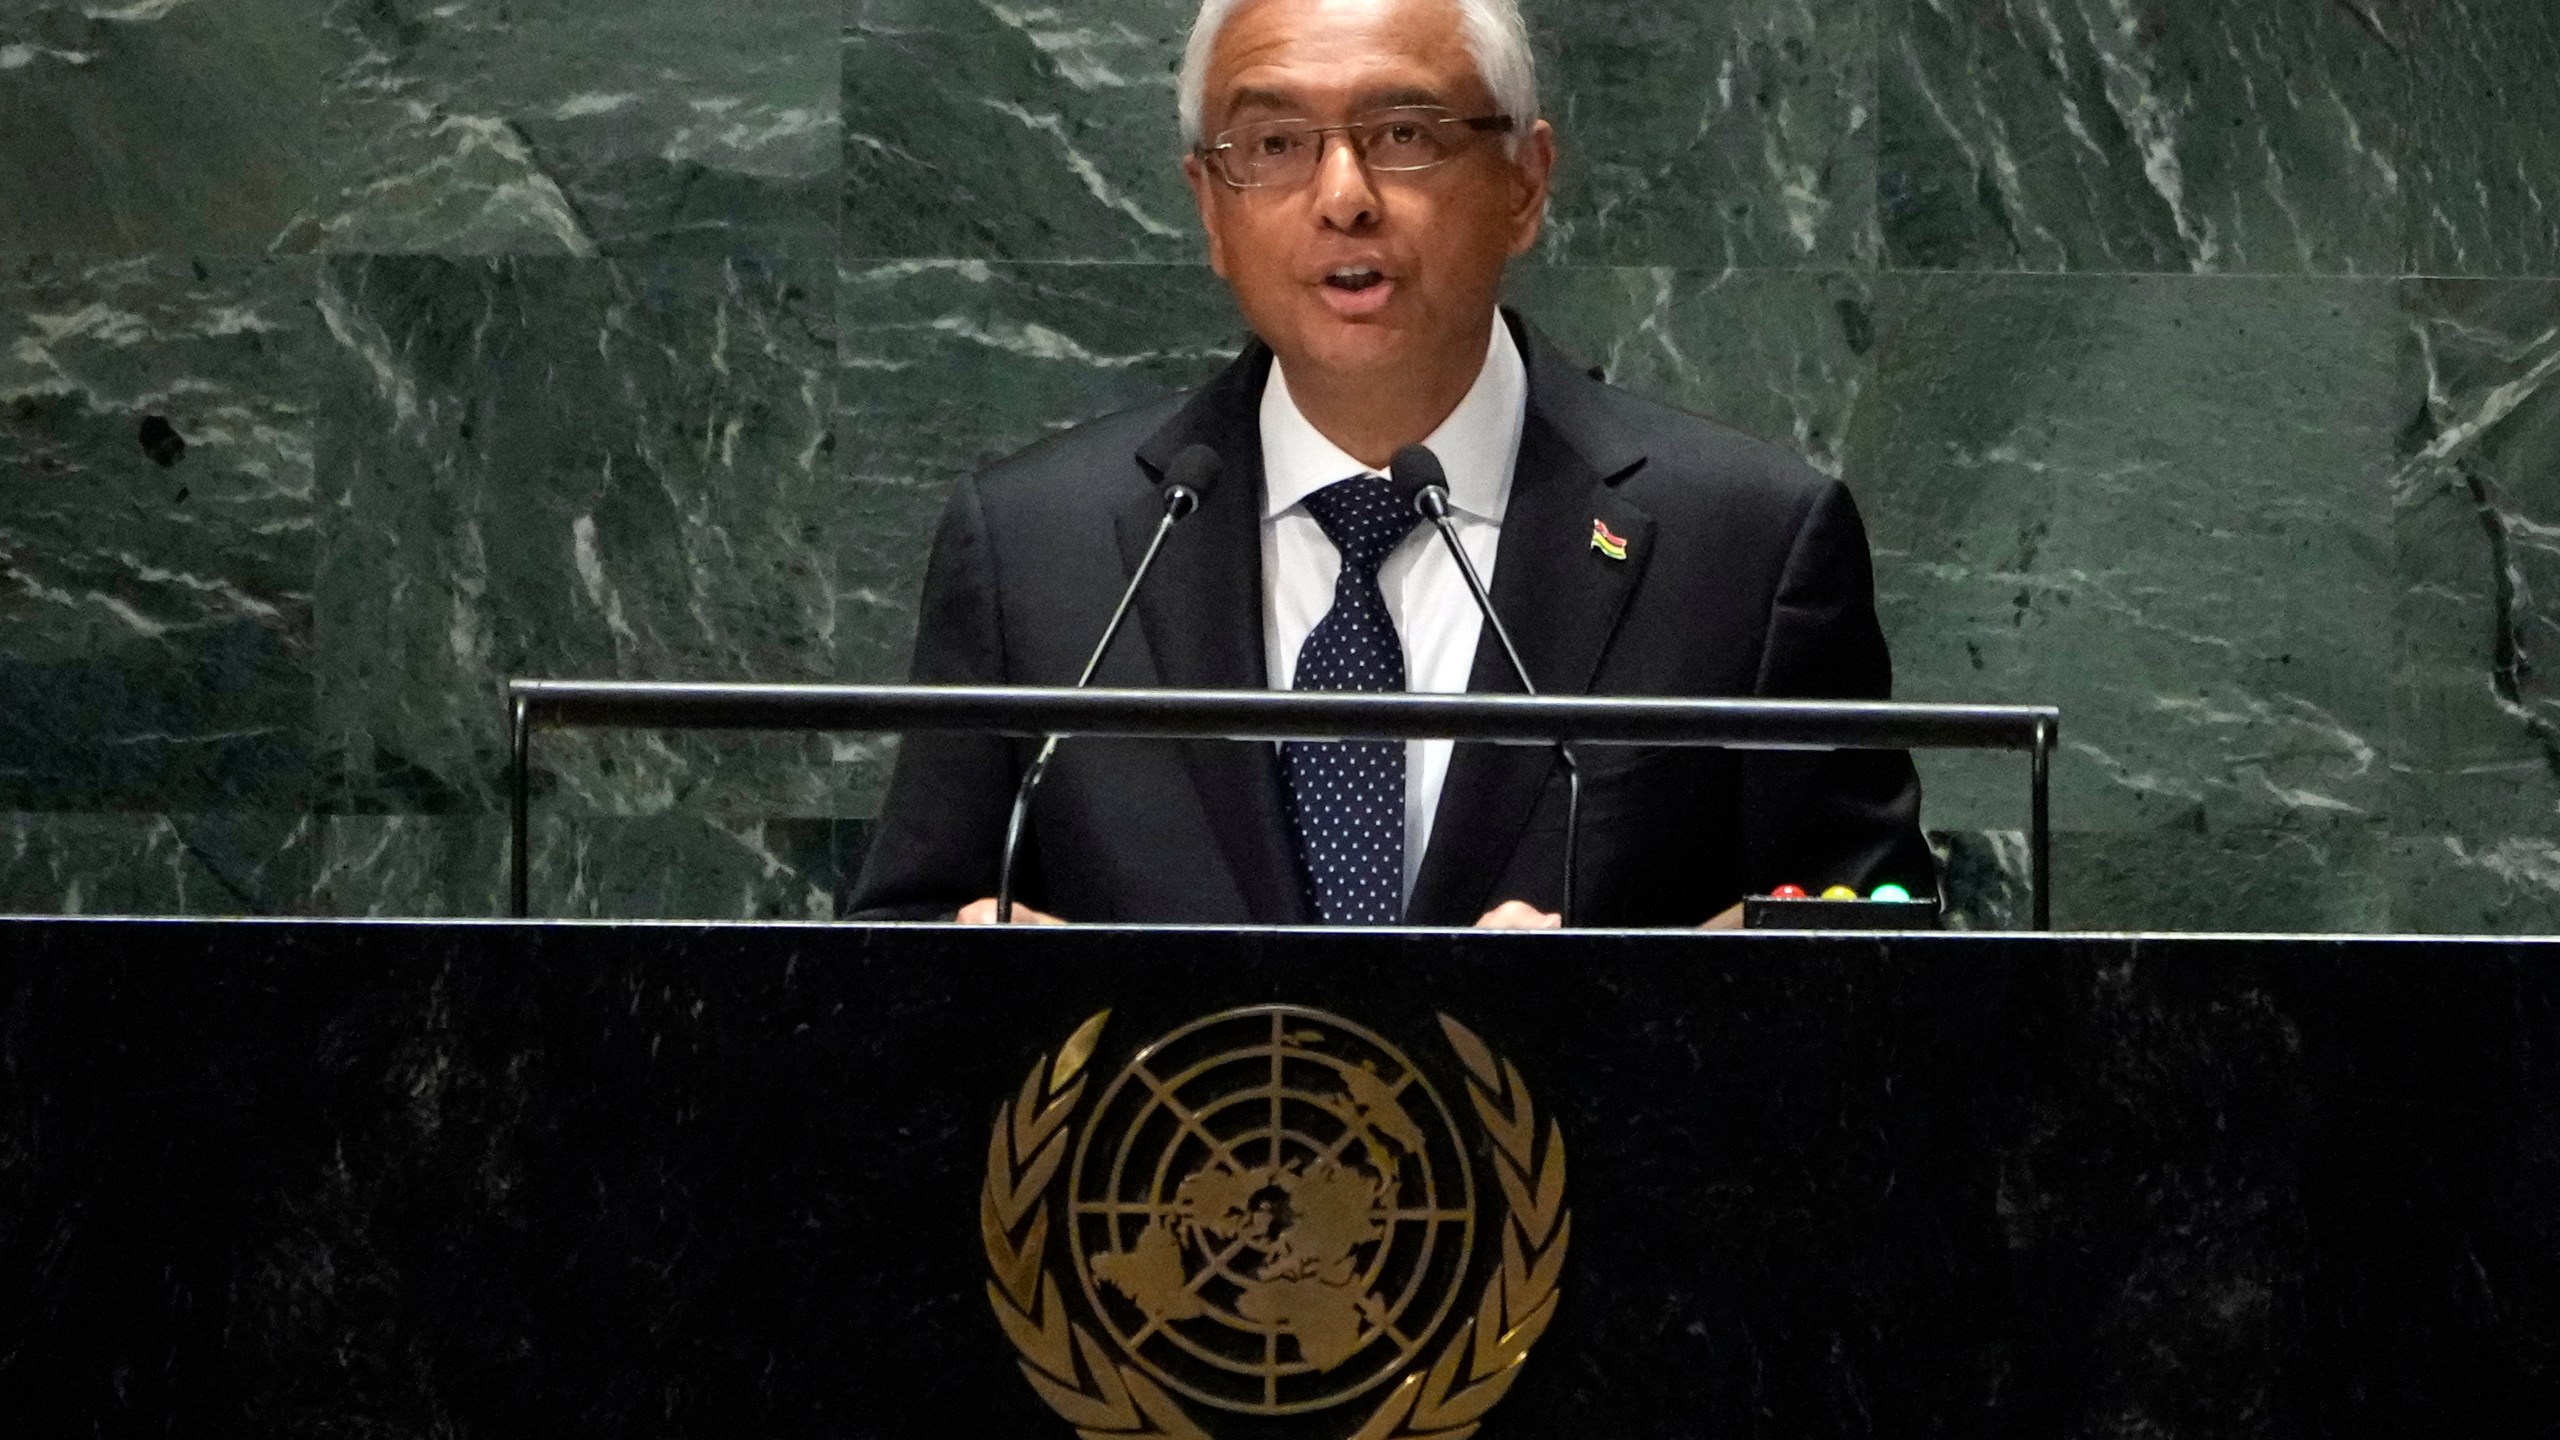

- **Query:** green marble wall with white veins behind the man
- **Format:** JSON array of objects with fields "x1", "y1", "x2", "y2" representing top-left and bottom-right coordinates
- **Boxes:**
[{"x1": 0, "y1": 0, "x2": 2560, "y2": 930}]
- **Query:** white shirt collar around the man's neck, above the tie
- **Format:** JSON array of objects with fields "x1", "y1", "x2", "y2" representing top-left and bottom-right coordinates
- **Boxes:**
[{"x1": 1262, "y1": 315, "x2": 1528, "y2": 523}]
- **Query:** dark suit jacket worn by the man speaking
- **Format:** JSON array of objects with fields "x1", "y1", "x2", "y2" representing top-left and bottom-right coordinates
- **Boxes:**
[{"x1": 852, "y1": 318, "x2": 1935, "y2": 925}]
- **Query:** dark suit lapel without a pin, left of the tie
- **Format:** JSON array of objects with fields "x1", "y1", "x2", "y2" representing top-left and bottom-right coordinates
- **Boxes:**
[{"x1": 1114, "y1": 343, "x2": 1306, "y2": 925}]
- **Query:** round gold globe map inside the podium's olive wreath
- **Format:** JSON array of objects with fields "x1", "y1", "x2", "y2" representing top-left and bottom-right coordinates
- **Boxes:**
[{"x1": 1068, "y1": 1004, "x2": 1477, "y2": 1414}]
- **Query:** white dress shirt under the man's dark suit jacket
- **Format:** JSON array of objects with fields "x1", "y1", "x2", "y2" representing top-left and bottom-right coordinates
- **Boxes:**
[{"x1": 1262, "y1": 318, "x2": 1528, "y2": 902}]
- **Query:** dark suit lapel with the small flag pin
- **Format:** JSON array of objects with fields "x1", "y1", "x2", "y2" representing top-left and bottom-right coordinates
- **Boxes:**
[{"x1": 1408, "y1": 323, "x2": 1654, "y2": 925}]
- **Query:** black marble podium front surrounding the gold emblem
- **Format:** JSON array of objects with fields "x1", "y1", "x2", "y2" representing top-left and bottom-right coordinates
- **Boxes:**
[{"x1": 0, "y1": 920, "x2": 2560, "y2": 1440}]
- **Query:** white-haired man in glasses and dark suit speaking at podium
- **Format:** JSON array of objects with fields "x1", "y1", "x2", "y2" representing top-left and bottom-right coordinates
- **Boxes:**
[{"x1": 852, "y1": 0, "x2": 1933, "y2": 928}]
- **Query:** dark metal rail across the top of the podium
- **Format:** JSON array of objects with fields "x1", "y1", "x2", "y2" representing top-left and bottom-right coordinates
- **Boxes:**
[{"x1": 507, "y1": 679, "x2": 2061, "y2": 930}]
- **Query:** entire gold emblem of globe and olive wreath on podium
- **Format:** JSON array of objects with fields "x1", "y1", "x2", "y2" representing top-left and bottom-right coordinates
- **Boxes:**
[{"x1": 978, "y1": 1004, "x2": 1572, "y2": 1440}]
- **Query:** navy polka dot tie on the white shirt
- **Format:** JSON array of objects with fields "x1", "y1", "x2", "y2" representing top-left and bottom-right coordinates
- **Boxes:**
[{"x1": 1280, "y1": 474, "x2": 1416, "y2": 925}]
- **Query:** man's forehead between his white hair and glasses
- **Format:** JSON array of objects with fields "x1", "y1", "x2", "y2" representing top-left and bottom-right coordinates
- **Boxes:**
[{"x1": 1206, "y1": 0, "x2": 1487, "y2": 115}]
